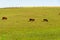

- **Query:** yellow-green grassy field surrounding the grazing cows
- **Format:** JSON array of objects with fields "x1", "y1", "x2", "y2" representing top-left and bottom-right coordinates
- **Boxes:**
[{"x1": 0, "y1": 7, "x2": 60, "y2": 40}]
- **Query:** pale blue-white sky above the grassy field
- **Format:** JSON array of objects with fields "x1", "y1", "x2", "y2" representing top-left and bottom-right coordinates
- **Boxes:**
[{"x1": 0, "y1": 0, "x2": 60, "y2": 8}]
